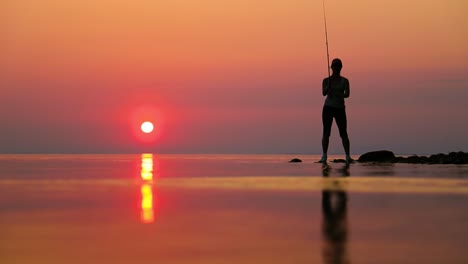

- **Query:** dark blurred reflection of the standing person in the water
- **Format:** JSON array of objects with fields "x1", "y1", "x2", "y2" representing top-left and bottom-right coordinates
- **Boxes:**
[{"x1": 322, "y1": 164, "x2": 350, "y2": 264}]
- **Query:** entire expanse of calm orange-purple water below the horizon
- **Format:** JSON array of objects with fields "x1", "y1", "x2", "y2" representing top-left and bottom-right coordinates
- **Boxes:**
[{"x1": 0, "y1": 155, "x2": 468, "y2": 263}]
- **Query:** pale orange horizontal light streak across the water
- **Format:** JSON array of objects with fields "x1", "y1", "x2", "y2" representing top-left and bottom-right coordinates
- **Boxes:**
[{"x1": 0, "y1": 176, "x2": 468, "y2": 194}]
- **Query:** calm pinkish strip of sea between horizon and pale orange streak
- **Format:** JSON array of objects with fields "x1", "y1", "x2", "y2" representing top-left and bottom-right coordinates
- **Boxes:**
[{"x1": 0, "y1": 154, "x2": 468, "y2": 180}]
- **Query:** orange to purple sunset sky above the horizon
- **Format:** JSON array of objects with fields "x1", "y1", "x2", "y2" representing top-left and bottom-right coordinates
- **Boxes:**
[{"x1": 0, "y1": 0, "x2": 468, "y2": 154}]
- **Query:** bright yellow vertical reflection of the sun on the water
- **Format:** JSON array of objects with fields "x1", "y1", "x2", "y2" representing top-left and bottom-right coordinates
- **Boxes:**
[{"x1": 140, "y1": 154, "x2": 158, "y2": 224}]
